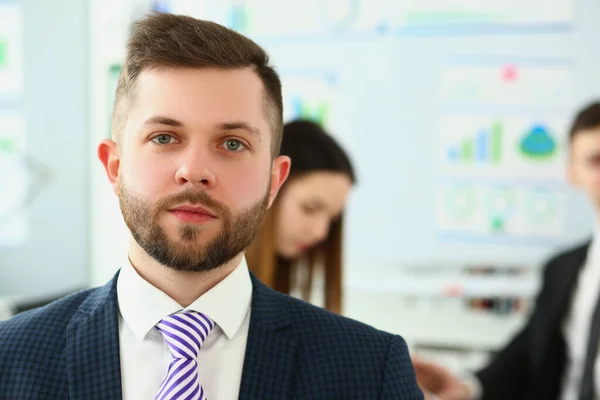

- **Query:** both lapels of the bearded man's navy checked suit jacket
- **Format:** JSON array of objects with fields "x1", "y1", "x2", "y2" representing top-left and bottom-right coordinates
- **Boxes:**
[{"x1": 65, "y1": 273, "x2": 297, "y2": 400}]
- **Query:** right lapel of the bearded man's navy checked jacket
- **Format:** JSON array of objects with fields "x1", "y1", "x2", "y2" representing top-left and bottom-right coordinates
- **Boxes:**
[{"x1": 239, "y1": 275, "x2": 297, "y2": 400}]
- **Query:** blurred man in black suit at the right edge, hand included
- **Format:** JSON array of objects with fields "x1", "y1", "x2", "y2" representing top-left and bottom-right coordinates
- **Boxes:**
[{"x1": 413, "y1": 102, "x2": 600, "y2": 400}]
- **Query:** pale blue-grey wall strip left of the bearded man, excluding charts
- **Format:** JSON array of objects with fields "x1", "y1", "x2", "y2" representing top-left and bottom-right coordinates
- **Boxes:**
[{"x1": 0, "y1": 0, "x2": 91, "y2": 297}]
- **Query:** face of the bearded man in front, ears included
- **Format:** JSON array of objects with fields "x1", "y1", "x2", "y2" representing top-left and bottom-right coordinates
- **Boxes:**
[{"x1": 99, "y1": 69, "x2": 289, "y2": 271}]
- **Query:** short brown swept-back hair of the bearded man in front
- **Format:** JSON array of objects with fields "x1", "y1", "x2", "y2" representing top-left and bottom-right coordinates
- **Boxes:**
[{"x1": 112, "y1": 13, "x2": 283, "y2": 155}]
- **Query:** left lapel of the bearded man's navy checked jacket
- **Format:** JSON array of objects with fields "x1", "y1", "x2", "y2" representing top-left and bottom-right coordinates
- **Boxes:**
[{"x1": 66, "y1": 274, "x2": 122, "y2": 400}]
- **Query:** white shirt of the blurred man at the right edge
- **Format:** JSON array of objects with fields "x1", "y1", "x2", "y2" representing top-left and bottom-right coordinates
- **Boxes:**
[{"x1": 560, "y1": 234, "x2": 600, "y2": 400}]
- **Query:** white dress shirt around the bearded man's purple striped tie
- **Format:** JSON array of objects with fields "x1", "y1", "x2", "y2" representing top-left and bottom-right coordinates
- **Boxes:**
[{"x1": 117, "y1": 260, "x2": 252, "y2": 400}]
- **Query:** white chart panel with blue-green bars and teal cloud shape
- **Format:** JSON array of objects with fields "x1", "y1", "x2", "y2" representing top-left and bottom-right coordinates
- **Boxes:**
[{"x1": 438, "y1": 114, "x2": 567, "y2": 180}]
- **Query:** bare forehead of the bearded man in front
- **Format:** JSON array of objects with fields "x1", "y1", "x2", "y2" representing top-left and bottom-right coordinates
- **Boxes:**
[{"x1": 128, "y1": 68, "x2": 269, "y2": 133}]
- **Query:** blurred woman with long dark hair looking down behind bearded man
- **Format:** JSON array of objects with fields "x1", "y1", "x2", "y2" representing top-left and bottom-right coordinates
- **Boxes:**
[{"x1": 246, "y1": 120, "x2": 356, "y2": 313}]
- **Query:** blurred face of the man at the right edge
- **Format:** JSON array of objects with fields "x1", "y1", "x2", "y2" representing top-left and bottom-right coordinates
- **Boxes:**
[{"x1": 569, "y1": 127, "x2": 600, "y2": 207}]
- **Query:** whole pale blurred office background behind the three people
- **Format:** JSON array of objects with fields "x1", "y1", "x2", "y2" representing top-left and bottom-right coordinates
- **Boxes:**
[{"x1": 0, "y1": 0, "x2": 600, "y2": 374}]
